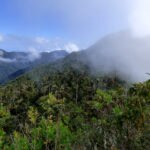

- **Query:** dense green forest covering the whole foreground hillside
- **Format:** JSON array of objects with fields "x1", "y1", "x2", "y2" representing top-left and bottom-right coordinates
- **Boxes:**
[{"x1": 0, "y1": 56, "x2": 150, "y2": 150}]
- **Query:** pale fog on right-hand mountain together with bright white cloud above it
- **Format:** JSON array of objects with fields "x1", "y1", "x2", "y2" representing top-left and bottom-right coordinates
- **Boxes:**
[{"x1": 83, "y1": 0, "x2": 150, "y2": 82}]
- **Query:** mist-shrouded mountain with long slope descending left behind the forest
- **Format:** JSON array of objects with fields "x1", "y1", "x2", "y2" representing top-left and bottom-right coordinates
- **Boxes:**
[{"x1": 12, "y1": 31, "x2": 150, "y2": 82}]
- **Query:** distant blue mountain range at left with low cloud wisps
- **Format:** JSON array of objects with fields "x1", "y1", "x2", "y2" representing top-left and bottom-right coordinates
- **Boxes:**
[{"x1": 0, "y1": 49, "x2": 68, "y2": 83}]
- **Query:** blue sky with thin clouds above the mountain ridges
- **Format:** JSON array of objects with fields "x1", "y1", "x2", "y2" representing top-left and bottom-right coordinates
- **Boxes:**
[{"x1": 0, "y1": 0, "x2": 135, "y2": 51}]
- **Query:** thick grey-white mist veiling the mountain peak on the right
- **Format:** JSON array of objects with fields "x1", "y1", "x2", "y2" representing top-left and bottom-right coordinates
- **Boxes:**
[{"x1": 85, "y1": 30, "x2": 150, "y2": 82}]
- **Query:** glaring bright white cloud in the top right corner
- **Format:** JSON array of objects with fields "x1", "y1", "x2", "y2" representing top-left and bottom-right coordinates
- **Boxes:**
[{"x1": 129, "y1": 0, "x2": 150, "y2": 37}]
